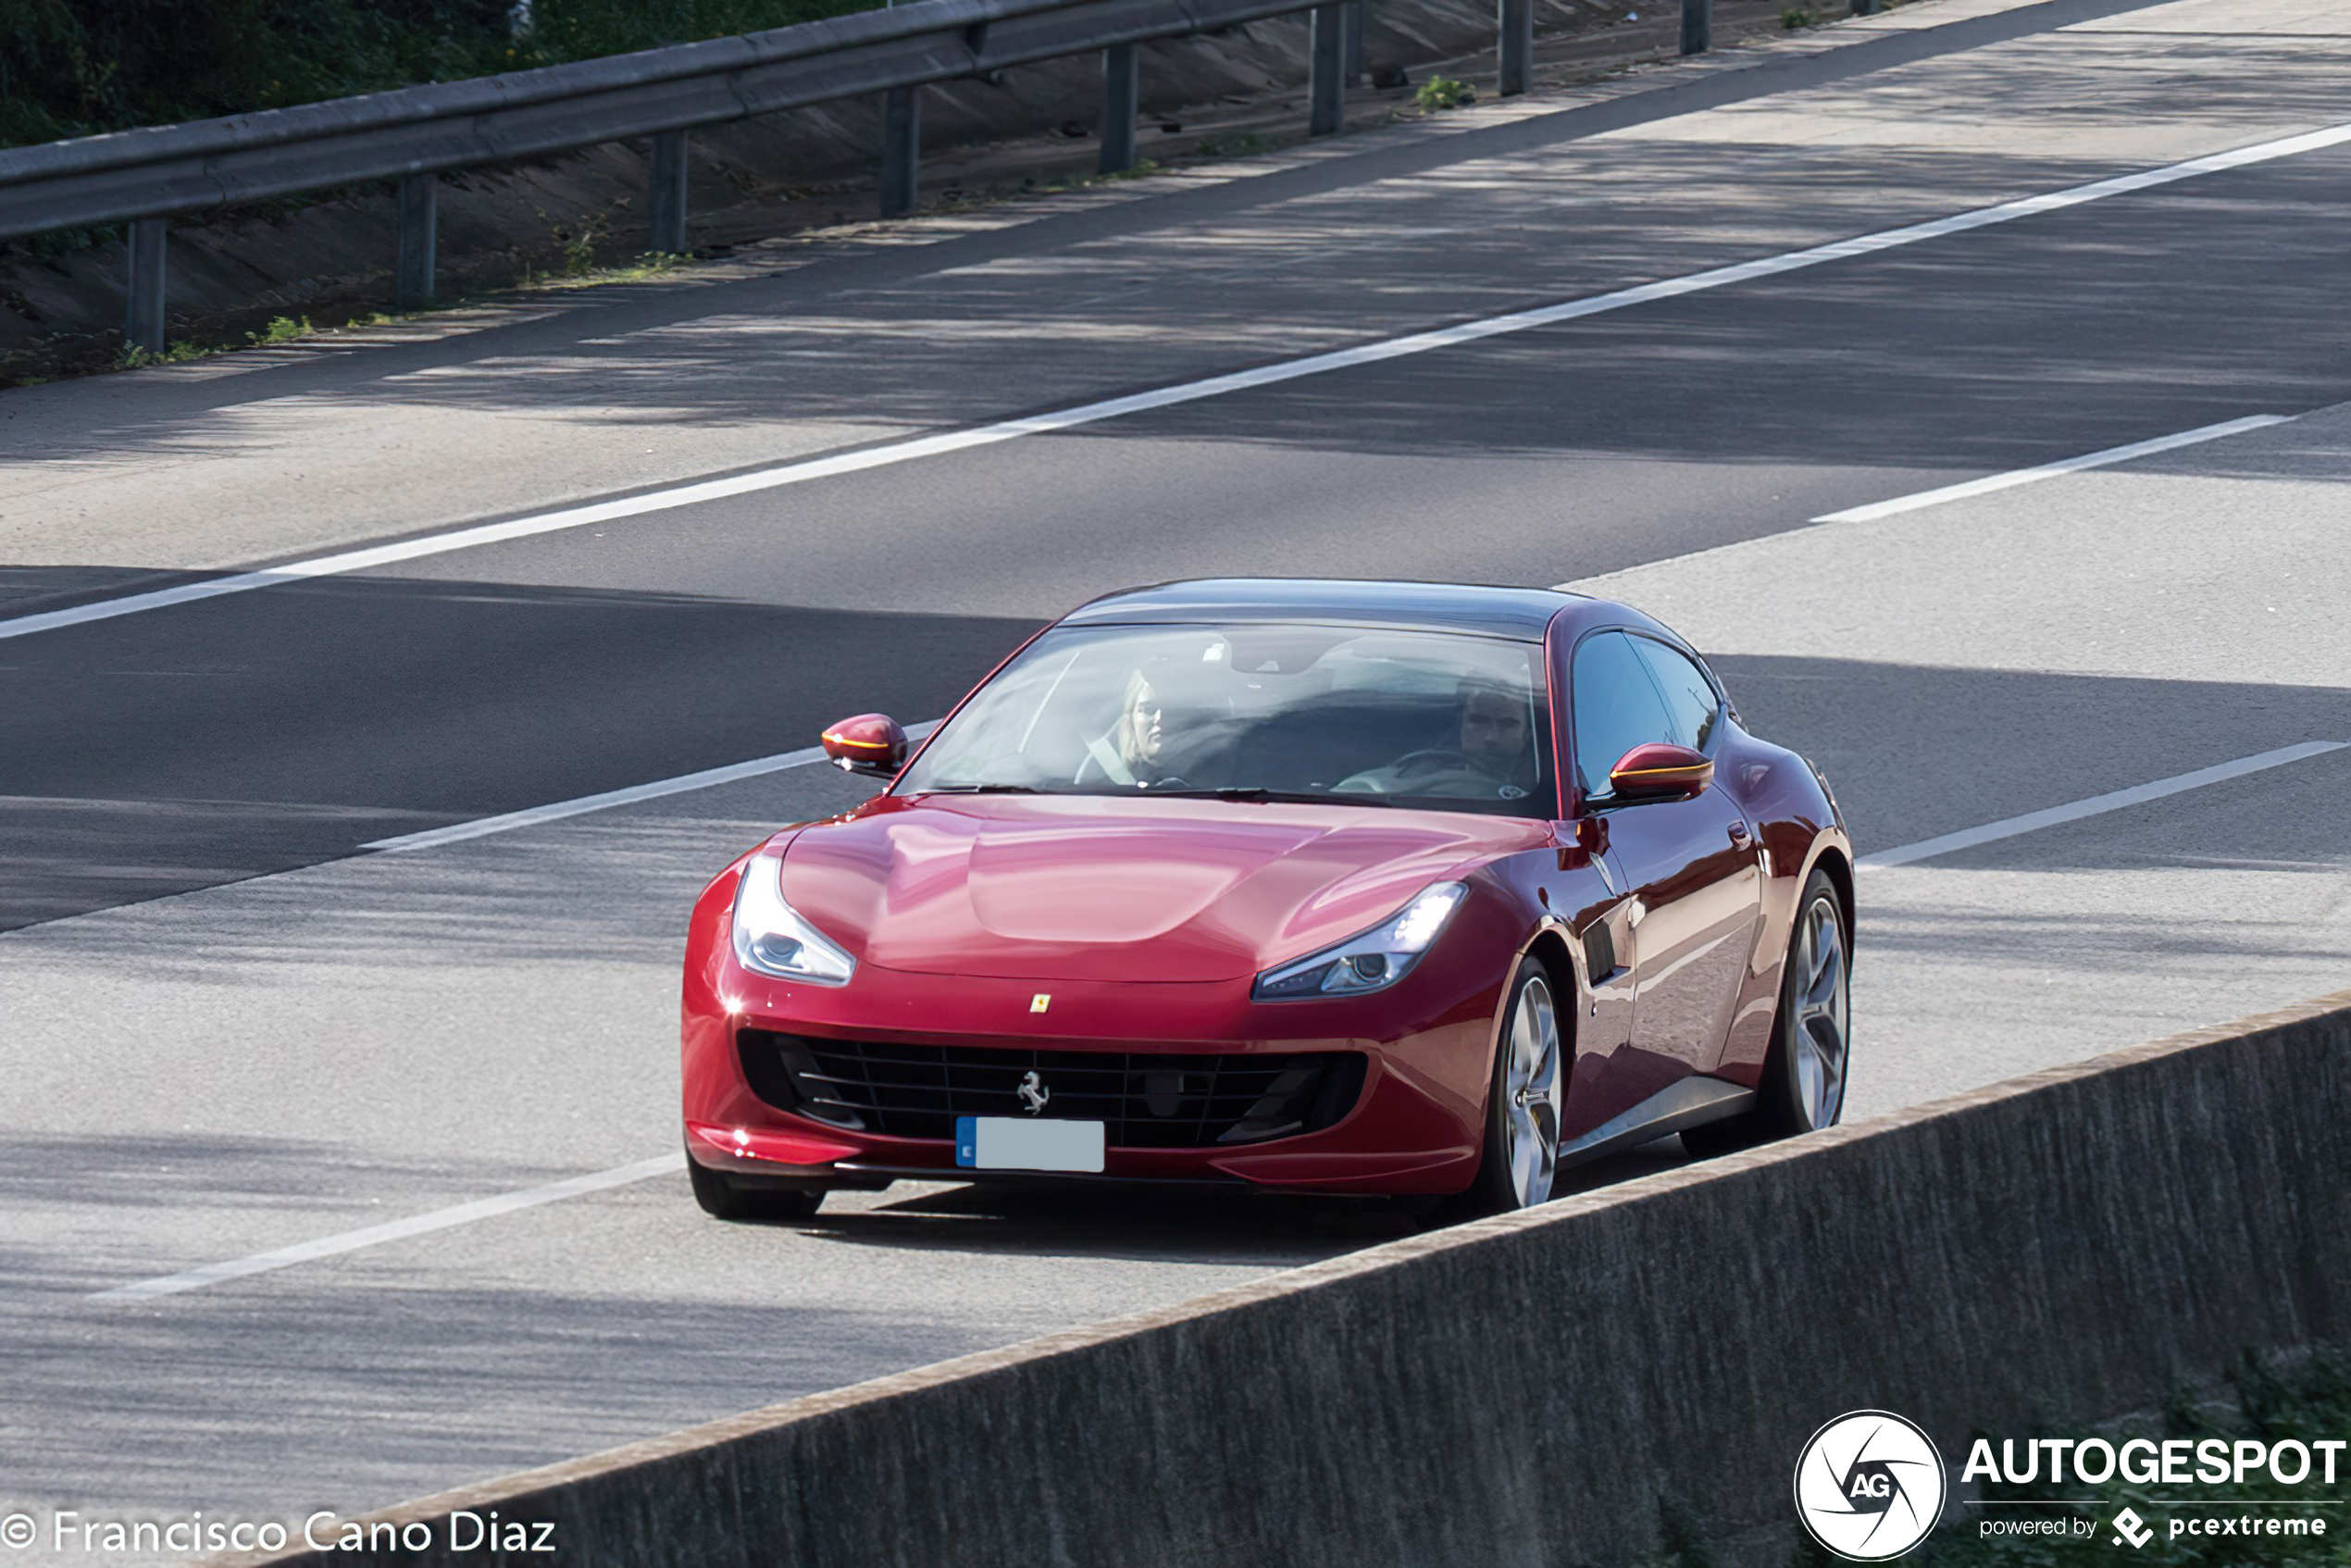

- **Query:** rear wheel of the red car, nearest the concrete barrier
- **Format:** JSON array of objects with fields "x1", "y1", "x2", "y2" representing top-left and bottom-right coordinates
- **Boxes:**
[{"x1": 1681, "y1": 867, "x2": 1853, "y2": 1159}]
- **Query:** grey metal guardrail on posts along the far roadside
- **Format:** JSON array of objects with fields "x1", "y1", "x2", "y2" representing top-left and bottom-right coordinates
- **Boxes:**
[{"x1": 0, "y1": 0, "x2": 1711, "y2": 355}]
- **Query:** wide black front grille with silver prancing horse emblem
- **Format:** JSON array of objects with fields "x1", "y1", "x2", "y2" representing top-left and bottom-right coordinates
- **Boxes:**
[{"x1": 736, "y1": 1029, "x2": 1363, "y2": 1150}]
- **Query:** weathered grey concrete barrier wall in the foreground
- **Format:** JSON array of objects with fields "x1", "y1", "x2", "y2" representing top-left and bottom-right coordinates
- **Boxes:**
[{"x1": 233, "y1": 992, "x2": 2351, "y2": 1568}]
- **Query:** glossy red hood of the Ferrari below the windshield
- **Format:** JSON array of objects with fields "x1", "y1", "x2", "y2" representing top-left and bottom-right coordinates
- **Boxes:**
[{"x1": 783, "y1": 794, "x2": 1549, "y2": 980}]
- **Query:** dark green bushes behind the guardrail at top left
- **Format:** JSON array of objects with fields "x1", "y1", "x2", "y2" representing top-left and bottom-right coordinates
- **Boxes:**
[{"x1": 0, "y1": 0, "x2": 872, "y2": 145}]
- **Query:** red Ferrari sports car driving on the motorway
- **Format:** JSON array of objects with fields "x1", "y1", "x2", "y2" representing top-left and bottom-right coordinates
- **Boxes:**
[{"x1": 684, "y1": 580, "x2": 1853, "y2": 1218}]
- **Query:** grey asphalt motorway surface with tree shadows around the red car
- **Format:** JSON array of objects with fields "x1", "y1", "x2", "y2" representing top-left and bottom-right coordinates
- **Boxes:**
[{"x1": 0, "y1": 0, "x2": 2351, "y2": 1561}]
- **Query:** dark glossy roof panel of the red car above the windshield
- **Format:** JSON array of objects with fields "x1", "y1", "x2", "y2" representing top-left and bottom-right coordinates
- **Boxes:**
[{"x1": 1063, "y1": 579, "x2": 1582, "y2": 641}]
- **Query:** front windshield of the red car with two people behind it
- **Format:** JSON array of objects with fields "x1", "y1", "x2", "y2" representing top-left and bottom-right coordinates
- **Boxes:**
[{"x1": 898, "y1": 626, "x2": 1556, "y2": 815}]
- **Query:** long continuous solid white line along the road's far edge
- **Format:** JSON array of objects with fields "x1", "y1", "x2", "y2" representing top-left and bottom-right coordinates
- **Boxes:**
[{"x1": 13, "y1": 122, "x2": 2351, "y2": 637}]
